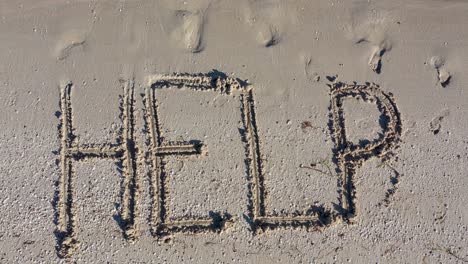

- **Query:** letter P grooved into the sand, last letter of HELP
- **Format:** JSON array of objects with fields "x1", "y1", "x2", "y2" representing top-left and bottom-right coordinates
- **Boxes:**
[{"x1": 329, "y1": 83, "x2": 401, "y2": 217}]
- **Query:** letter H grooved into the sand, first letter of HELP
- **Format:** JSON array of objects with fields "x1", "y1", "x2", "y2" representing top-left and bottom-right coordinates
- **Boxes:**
[{"x1": 54, "y1": 81, "x2": 138, "y2": 257}]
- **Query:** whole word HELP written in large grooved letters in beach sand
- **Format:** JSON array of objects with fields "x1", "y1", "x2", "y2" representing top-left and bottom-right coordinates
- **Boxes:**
[{"x1": 55, "y1": 71, "x2": 401, "y2": 257}]
